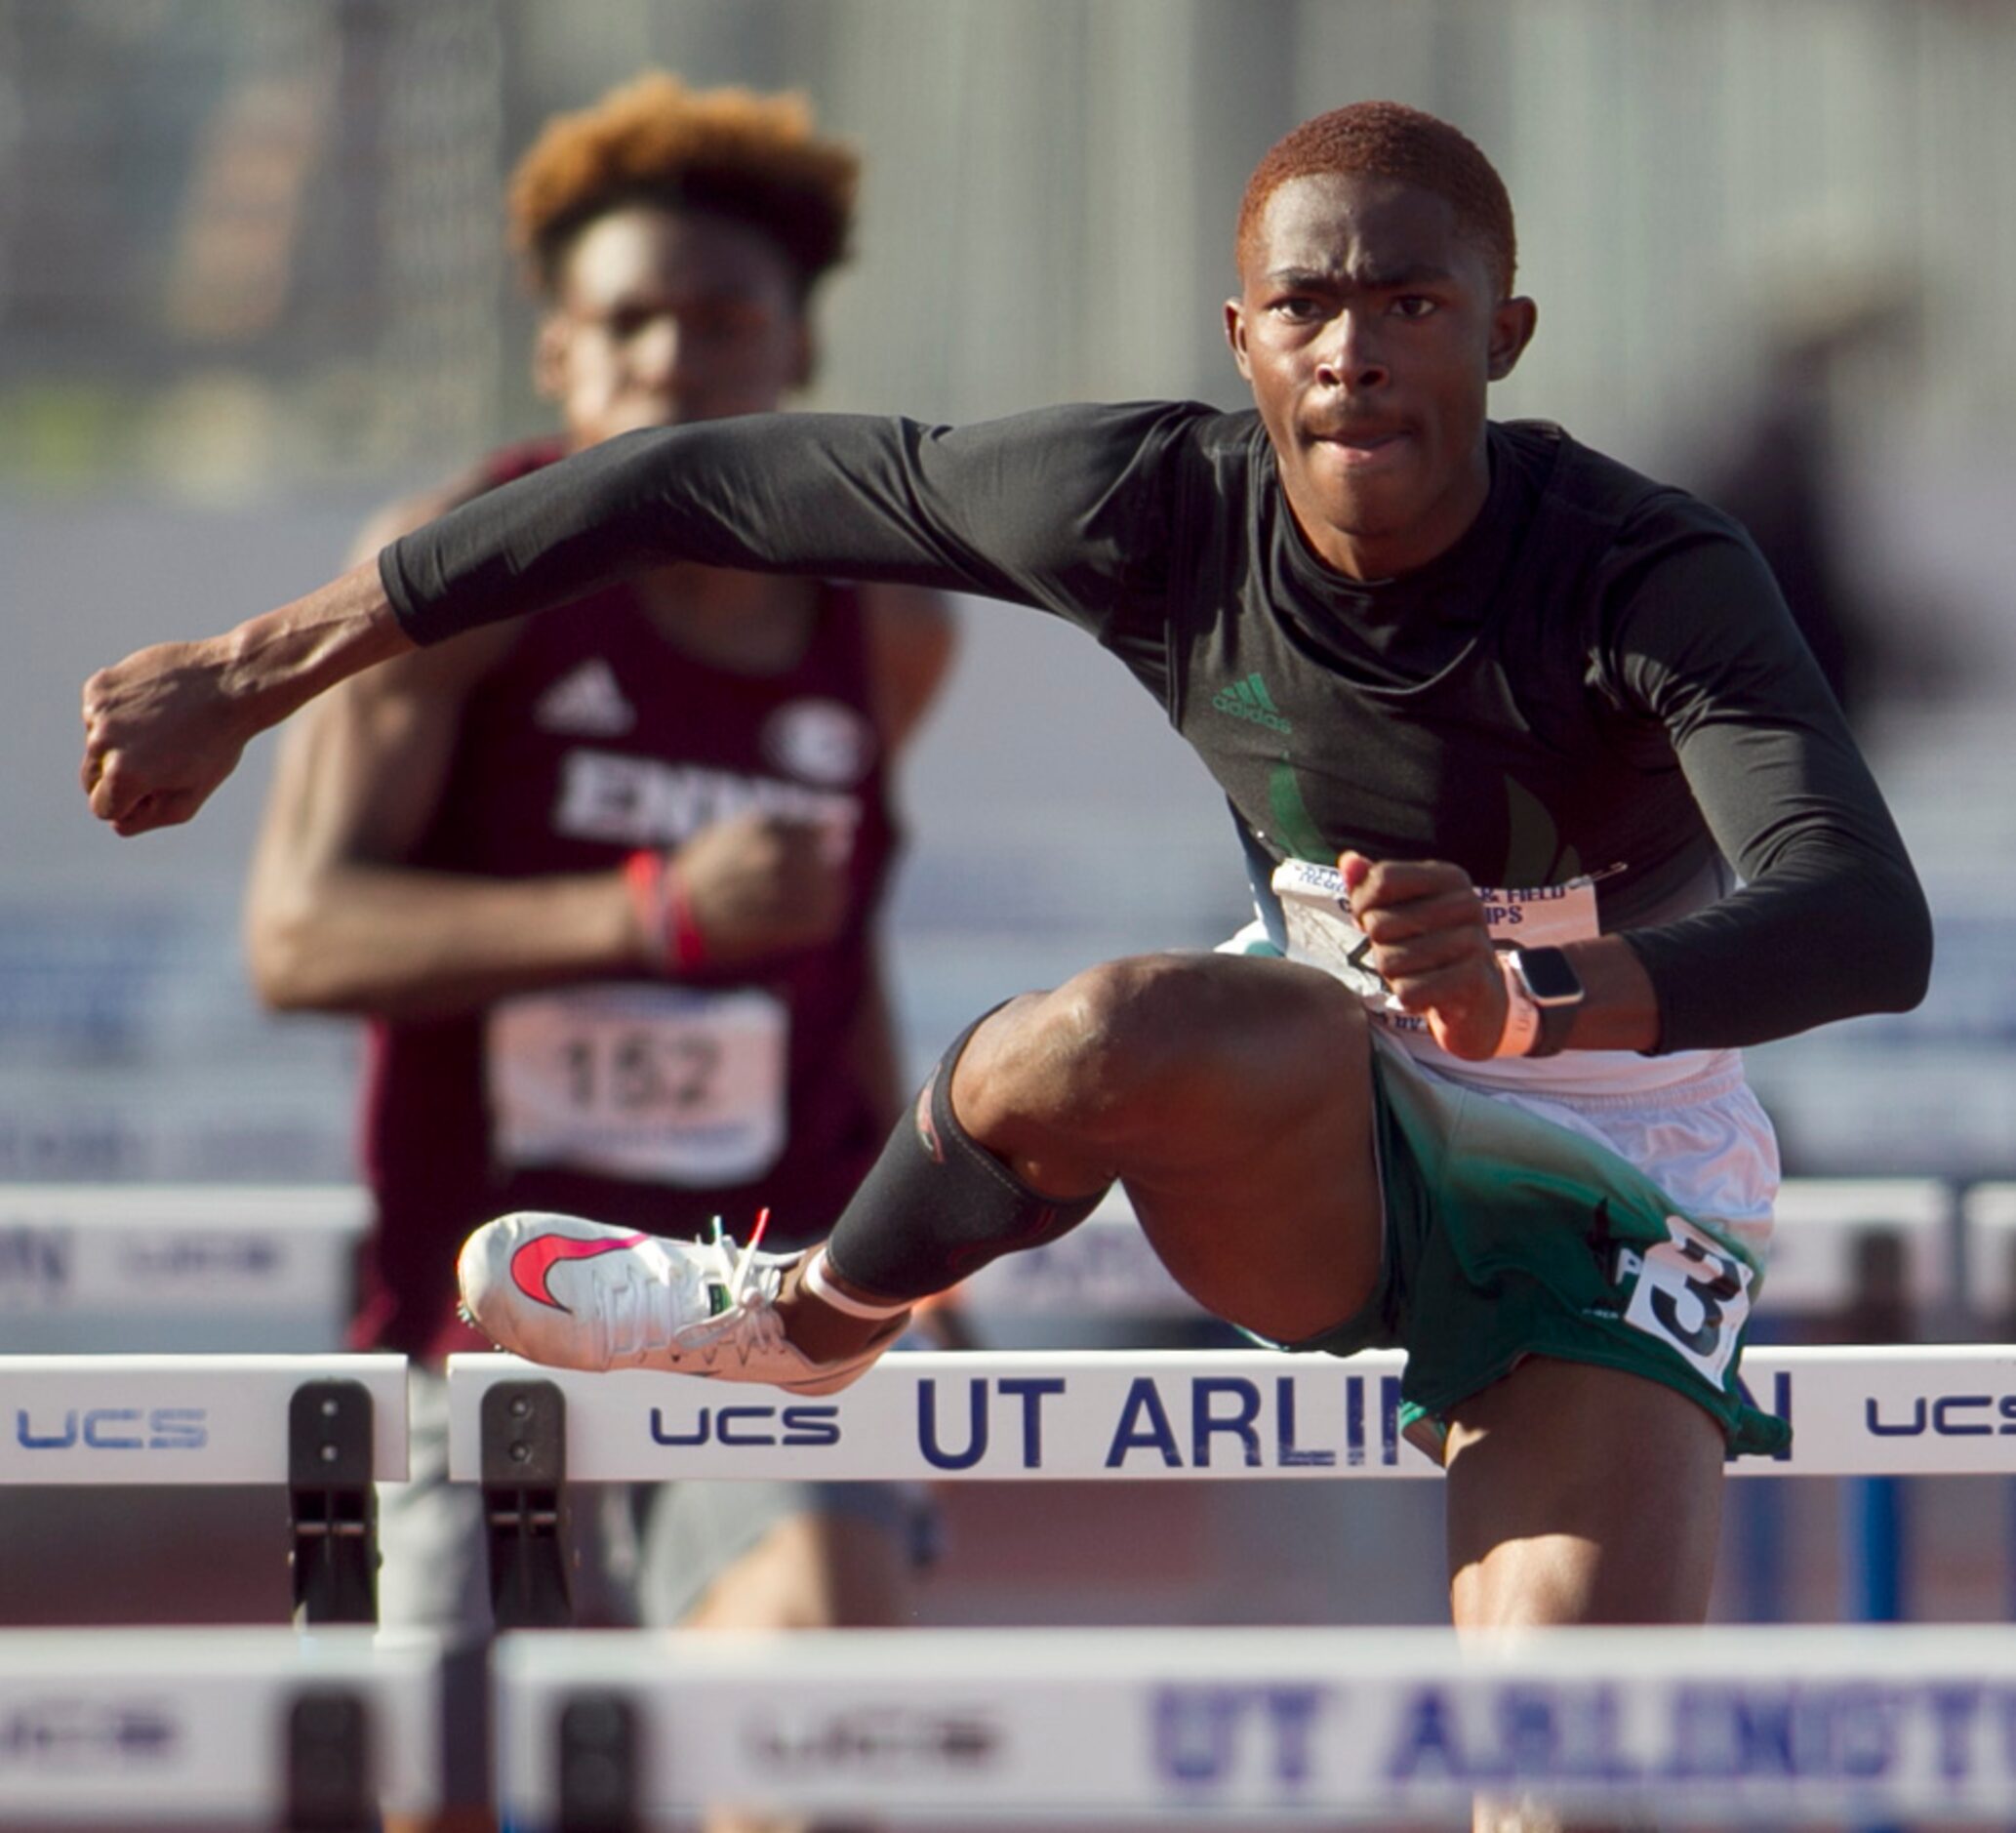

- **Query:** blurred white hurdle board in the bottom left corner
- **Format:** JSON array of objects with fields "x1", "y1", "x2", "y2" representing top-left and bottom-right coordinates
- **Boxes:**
[{"x1": 0, "y1": 1629, "x2": 441, "y2": 1829}]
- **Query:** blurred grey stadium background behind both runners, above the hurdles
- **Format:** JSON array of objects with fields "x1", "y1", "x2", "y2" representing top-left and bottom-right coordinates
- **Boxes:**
[{"x1": 0, "y1": 0, "x2": 2016, "y2": 1615}]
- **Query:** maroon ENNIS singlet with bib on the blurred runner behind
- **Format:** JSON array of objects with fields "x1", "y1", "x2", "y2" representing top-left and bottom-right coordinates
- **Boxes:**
[{"x1": 353, "y1": 446, "x2": 897, "y2": 1357}]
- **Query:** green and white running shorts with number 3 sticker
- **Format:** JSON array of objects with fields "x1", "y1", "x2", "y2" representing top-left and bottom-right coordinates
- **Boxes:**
[{"x1": 1282, "y1": 1037, "x2": 1791, "y2": 1456}]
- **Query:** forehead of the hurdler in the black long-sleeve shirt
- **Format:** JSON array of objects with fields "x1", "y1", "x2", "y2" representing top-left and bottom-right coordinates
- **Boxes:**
[{"x1": 1240, "y1": 172, "x2": 1488, "y2": 300}]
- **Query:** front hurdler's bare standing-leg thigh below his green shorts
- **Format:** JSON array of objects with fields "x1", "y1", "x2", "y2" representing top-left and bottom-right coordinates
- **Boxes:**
[{"x1": 1447, "y1": 1357, "x2": 1725, "y2": 1627}]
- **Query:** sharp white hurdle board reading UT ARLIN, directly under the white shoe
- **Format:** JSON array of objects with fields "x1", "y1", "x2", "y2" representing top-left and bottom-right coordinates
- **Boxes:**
[{"x1": 448, "y1": 1343, "x2": 2016, "y2": 1483}]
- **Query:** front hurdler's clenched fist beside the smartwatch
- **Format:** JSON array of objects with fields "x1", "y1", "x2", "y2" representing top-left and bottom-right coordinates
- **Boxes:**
[{"x1": 1337, "y1": 853, "x2": 1510, "y2": 1063}]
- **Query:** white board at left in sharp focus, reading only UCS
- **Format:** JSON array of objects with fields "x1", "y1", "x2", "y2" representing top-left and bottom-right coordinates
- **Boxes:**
[{"x1": 0, "y1": 1355, "x2": 407, "y2": 1485}]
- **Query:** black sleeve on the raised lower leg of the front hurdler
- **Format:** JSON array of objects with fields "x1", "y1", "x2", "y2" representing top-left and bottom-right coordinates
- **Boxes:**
[{"x1": 827, "y1": 1014, "x2": 1105, "y2": 1299}]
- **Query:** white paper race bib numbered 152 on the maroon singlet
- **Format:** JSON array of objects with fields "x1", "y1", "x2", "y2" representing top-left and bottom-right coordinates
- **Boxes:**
[{"x1": 486, "y1": 986, "x2": 790, "y2": 1186}]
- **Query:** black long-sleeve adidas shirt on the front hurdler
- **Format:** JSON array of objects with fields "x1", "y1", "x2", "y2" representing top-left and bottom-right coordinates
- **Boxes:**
[{"x1": 381, "y1": 403, "x2": 1931, "y2": 1050}]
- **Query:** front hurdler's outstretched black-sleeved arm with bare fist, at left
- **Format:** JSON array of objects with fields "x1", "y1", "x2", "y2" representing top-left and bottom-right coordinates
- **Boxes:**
[{"x1": 83, "y1": 403, "x2": 1177, "y2": 835}]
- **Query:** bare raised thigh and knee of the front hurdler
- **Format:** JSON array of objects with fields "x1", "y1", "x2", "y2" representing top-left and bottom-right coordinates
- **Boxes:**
[{"x1": 951, "y1": 954, "x2": 1381, "y2": 1343}]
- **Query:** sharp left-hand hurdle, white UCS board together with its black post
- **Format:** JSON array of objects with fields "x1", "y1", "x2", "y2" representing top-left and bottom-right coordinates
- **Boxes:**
[{"x1": 0, "y1": 1355, "x2": 407, "y2": 1623}]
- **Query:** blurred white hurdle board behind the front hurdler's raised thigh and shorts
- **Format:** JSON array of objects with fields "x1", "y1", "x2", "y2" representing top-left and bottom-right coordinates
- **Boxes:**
[{"x1": 961, "y1": 1178, "x2": 1959, "y2": 1321}]
